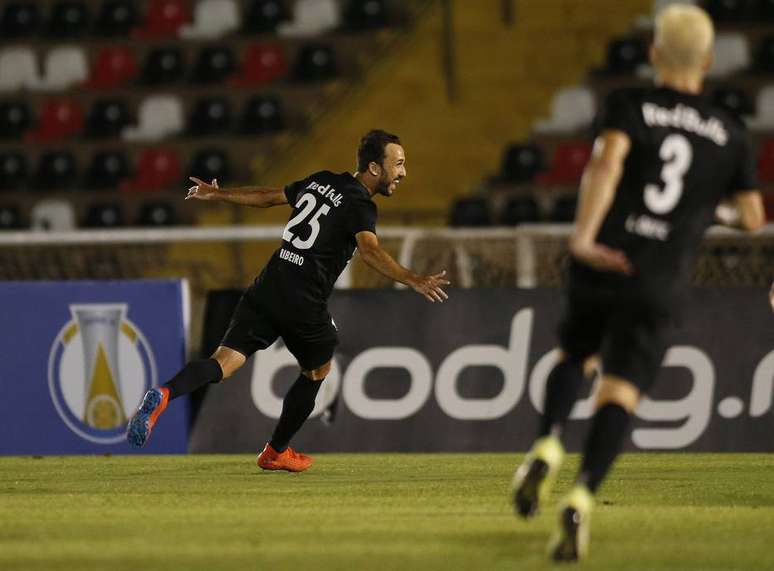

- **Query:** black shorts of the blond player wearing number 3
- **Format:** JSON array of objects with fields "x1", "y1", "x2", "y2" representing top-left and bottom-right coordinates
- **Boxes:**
[{"x1": 559, "y1": 272, "x2": 671, "y2": 394}]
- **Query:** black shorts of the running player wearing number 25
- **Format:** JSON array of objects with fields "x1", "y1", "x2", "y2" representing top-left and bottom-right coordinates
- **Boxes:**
[{"x1": 220, "y1": 285, "x2": 339, "y2": 371}]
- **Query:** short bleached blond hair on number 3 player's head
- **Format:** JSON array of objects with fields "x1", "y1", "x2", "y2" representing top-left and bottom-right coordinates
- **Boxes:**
[{"x1": 653, "y1": 4, "x2": 715, "y2": 70}]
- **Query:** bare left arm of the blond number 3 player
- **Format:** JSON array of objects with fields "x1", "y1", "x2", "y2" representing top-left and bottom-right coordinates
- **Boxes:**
[{"x1": 570, "y1": 129, "x2": 632, "y2": 274}]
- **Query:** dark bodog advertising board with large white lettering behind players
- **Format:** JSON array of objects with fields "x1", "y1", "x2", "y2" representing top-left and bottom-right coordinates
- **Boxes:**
[{"x1": 191, "y1": 288, "x2": 774, "y2": 452}]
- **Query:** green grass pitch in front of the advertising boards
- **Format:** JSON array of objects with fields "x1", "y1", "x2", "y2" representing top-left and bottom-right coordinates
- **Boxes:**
[{"x1": 0, "y1": 454, "x2": 774, "y2": 571}]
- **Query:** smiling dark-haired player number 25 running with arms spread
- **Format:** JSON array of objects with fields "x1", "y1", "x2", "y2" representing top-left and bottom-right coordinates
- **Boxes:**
[{"x1": 126, "y1": 130, "x2": 449, "y2": 472}]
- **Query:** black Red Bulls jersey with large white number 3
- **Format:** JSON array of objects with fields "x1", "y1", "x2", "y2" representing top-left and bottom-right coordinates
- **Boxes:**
[{"x1": 575, "y1": 88, "x2": 757, "y2": 293}]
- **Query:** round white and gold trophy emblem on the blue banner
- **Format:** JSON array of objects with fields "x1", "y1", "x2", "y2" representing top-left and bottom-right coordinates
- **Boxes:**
[{"x1": 48, "y1": 303, "x2": 157, "y2": 444}]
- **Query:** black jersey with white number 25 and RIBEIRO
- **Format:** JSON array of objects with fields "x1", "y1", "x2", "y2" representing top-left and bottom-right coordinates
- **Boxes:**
[{"x1": 256, "y1": 171, "x2": 377, "y2": 313}]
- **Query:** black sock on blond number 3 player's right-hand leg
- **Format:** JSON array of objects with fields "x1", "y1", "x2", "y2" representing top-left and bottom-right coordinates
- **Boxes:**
[{"x1": 578, "y1": 403, "x2": 631, "y2": 493}]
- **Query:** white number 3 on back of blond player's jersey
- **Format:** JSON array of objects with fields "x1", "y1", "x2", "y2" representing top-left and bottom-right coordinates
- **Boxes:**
[{"x1": 645, "y1": 134, "x2": 693, "y2": 214}]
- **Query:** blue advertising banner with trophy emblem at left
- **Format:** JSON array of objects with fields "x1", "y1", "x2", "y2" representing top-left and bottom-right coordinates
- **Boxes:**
[{"x1": 0, "y1": 280, "x2": 188, "y2": 454}]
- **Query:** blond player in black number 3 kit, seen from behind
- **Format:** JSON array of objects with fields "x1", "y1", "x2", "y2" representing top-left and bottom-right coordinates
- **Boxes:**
[{"x1": 512, "y1": 5, "x2": 764, "y2": 561}]
